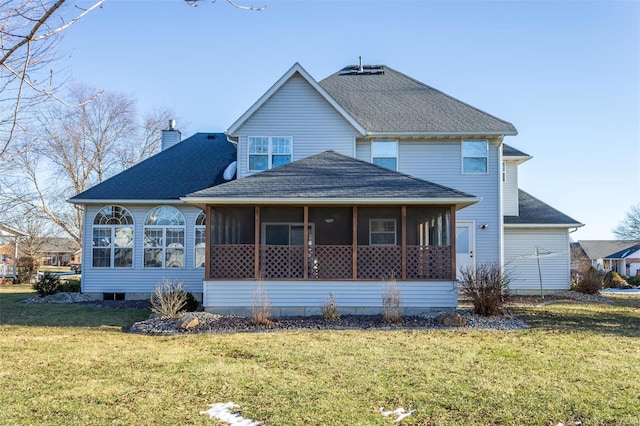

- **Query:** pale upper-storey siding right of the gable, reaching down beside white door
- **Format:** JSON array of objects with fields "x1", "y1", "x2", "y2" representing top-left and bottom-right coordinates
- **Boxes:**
[{"x1": 356, "y1": 139, "x2": 502, "y2": 264}]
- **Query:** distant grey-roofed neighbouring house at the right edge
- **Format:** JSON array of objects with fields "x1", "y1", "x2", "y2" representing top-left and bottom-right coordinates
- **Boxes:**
[{"x1": 578, "y1": 240, "x2": 640, "y2": 276}]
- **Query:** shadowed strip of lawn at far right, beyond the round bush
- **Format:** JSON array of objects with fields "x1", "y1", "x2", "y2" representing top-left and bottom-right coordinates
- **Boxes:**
[{"x1": 513, "y1": 297, "x2": 640, "y2": 337}]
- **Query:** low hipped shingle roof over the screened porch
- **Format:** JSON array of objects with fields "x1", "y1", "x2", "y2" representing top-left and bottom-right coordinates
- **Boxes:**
[{"x1": 181, "y1": 151, "x2": 480, "y2": 208}]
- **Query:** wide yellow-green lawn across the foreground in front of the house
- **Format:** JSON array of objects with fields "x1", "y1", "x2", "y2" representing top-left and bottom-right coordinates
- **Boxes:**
[{"x1": 0, "y1": 286, "x2": 640, "y2": 426}]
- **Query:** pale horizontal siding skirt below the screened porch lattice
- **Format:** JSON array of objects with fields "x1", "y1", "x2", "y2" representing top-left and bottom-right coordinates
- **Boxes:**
[{"x1": 203, "y1": 281, "x2": 458, "y2": 314}]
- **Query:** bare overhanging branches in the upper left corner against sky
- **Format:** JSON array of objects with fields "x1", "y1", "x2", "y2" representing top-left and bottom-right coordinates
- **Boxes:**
[{"x1": 0, "y1": 0, "x2": 103, "y2": 158}]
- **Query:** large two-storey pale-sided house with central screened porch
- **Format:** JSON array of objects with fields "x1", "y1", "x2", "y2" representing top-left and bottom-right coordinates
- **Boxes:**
[{"x1": 71, "y1": 60, "x2": 582, "y2": 314}]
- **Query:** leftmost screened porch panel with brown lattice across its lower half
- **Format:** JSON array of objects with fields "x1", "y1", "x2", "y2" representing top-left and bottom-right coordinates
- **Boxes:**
[{"x1": 209, "y1": 206, "x2": 254, "y2": 279}]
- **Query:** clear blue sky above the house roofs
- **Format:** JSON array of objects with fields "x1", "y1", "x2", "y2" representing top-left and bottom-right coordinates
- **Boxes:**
[{"x1": 57, "y1": 0, "x2": 640, "y2": 240}]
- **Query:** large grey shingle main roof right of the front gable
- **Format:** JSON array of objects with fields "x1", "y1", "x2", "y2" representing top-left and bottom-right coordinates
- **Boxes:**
[{"x1": 319, "y1": 66, "x2": 517, "y2": 134}]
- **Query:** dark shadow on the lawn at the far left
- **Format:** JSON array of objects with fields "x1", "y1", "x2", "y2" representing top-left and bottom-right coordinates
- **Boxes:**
[{"x1": 0, "y1": 292, "x2": 149, "y2": 327}]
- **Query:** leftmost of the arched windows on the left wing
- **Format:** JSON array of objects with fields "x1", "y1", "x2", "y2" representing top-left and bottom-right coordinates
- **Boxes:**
[{"x1": 92, "y1": 206, "x2": 133, "y2": 268}]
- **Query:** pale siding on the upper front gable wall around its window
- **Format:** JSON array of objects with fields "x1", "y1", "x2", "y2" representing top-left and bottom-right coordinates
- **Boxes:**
[{"x1": 233, "y1": 74, "x2": 357, "y2": 178}]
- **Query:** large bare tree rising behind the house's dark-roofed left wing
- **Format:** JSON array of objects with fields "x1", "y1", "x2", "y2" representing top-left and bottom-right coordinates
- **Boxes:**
[{"x1": 0, "y1": 86, "x2": 172, "y2": 244}]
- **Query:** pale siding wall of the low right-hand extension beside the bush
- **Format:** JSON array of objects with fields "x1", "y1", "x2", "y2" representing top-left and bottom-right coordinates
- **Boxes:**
[{"x1": 504, "y1": 228, "x2": 571, "y2": 294}]
